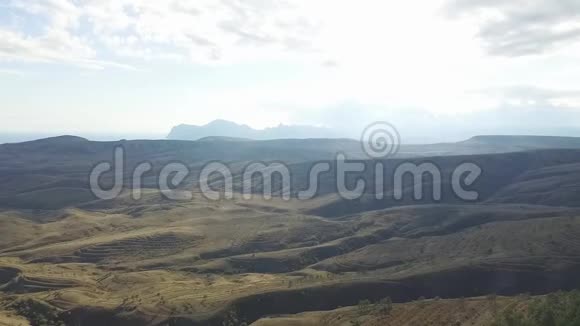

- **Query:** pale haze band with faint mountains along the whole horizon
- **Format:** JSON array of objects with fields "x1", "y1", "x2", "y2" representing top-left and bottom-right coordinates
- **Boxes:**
[{"x1": 5, "y1": 113, "x2": 580, "y2": 144}]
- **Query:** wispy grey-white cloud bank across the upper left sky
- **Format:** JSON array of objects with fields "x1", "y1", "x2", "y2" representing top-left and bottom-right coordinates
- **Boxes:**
[{"x1": 0, "y1": 0, "x2": 316, "y2": 63}]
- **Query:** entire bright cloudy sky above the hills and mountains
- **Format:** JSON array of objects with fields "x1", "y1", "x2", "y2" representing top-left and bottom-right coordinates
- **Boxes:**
[{"x1": 0, "y1": 0, "x2": 580, "y2": 139}]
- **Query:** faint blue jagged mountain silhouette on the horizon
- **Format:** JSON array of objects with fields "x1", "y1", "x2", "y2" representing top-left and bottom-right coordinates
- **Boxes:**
[{"x1": 167, "y1": 120, "x2": 340, "y2": 140}]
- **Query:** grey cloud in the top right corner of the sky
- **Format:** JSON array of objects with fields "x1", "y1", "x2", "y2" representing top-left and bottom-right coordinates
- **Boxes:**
[{"x1": 445, "y1": 0, "x2": 580, "y2": 57}]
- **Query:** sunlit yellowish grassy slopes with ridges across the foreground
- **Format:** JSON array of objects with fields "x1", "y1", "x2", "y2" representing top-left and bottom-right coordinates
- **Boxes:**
[{"x1": 0, "y1": 199, "x2": 580, "y2": 322}]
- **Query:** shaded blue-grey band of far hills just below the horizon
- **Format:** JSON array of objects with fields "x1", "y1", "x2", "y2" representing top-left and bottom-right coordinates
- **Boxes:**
[{"x1": 0, "y1": 136, "x2": 580, "y2": 211}]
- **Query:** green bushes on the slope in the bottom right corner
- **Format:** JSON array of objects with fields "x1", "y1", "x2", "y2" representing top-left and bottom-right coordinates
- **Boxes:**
[{"x1": 493, "y1": 291, "x2": 580, "y2": 326}]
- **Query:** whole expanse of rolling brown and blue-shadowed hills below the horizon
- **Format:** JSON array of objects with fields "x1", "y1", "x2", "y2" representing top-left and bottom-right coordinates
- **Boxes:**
[{"x1": 0, "y1": 137, "x2": 580, "y2": 326}]
